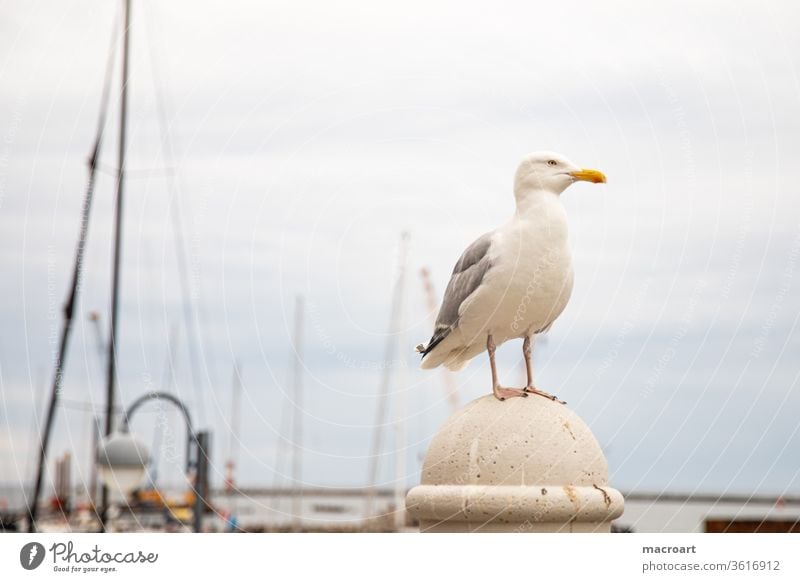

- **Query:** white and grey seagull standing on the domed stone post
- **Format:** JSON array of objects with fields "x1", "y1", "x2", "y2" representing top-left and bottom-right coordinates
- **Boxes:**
[{"x1": 416, "y1": 152, "x2": 606, "y2": 404}]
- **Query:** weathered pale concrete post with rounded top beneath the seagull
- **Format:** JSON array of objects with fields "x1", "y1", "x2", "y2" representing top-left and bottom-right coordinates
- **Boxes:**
[{"x1": 406, "y1": 395, "x2": 624, "y2": 532}]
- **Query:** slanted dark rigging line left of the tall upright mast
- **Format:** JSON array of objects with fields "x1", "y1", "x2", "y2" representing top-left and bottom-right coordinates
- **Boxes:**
[{"x1": 27, "y1": 5, "x2": 119, "y2": 533}]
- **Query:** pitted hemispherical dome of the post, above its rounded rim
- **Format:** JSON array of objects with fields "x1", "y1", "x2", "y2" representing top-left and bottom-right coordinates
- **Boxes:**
[{"x1": 422, "y1": 395, "x2": 608, "y2": 488}]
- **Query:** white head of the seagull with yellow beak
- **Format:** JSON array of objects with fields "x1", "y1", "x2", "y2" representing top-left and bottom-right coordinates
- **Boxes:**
[{"x1": 514, "y1": 152, "x2": 606, "y2": 197}]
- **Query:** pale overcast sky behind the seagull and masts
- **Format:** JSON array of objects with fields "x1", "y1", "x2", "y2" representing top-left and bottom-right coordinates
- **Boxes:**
[{"x1": 0, "y1": 0, "x2": 800, "y2": 504}]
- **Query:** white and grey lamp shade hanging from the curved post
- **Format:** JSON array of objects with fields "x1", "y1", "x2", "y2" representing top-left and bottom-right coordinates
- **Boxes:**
[{"x1": 97, "y1": 432, "x2": 148, "y2": 494}]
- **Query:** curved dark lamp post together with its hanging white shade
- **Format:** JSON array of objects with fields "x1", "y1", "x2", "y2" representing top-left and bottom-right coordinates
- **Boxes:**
[{"x1": 97, "y1": 392, "x2": 209, "y2": 532}]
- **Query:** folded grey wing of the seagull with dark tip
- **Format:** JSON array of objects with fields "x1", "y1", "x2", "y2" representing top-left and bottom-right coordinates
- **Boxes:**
[{"x1": 418, "y1": 232, "x2": 494, "y2": 357}]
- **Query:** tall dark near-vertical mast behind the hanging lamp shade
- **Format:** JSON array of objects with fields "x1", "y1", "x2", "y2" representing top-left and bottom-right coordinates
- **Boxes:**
[{"x1": 100, "y1": 0, "x2": 131, "y2": 530}]
